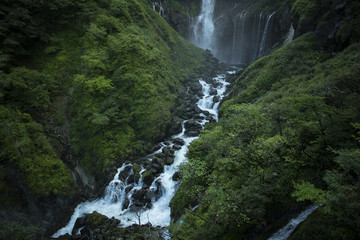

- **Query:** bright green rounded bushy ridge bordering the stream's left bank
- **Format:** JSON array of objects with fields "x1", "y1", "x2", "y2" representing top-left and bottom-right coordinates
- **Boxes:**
[{"x1": 70, "y1": 0, "x2": 204, "y2": 178}]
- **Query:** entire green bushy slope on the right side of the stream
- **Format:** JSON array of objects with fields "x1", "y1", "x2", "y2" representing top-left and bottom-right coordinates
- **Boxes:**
[{"x1": 171, "y1": 1, "x2": 360, "y2": 239}]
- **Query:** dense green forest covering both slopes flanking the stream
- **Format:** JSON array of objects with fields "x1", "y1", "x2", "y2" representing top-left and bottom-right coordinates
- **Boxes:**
[{"x1": 0, "y1": 0, "x2": 360, "y2": 240}]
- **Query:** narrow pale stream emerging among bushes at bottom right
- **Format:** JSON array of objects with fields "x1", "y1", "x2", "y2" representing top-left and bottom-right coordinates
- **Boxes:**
[{"x1": 268, "y1": 205, "x2": 319, "y2": 240}]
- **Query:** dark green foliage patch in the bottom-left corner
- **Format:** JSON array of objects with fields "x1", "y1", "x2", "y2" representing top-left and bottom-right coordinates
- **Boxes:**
[{"x1": 0, "y1": 221, "x2": 44, "y2": 240}]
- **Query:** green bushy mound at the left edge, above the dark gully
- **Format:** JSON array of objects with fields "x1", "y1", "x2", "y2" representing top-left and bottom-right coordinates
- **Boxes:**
[{"x1": 0, "y1": 106, "x2": 72, "y2": 197}]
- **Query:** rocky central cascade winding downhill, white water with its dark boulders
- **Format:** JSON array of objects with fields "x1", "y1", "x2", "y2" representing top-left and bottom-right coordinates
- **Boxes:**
[{"x1": 52, "y1": 72, "x2": 233, "y2": 238}]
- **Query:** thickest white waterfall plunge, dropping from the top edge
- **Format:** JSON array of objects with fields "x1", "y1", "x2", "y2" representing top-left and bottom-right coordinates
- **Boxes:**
[{"x1": 192, "y1": 0, "x2": 215, "y2": 51}]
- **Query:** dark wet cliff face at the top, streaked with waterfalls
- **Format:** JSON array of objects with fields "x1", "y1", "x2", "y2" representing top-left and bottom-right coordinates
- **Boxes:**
[{"x1": 153, "y1": 1, "x2": 291, "y2": 65}]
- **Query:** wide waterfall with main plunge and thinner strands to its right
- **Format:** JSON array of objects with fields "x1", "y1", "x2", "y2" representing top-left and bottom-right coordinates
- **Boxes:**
[{"x1": 189, "y1": 0, "x2": 286, "y2": 65}]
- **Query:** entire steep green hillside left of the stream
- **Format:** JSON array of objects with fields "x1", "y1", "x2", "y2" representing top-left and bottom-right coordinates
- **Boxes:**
[{"x1": 0, "y1": 0, "x2": 209, "y2": 237}]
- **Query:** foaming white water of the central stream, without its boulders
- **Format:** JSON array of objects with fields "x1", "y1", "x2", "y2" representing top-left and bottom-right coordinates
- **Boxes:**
[{"x1": 52, "y1": 74, "x2": 229, "y2": 238}]
